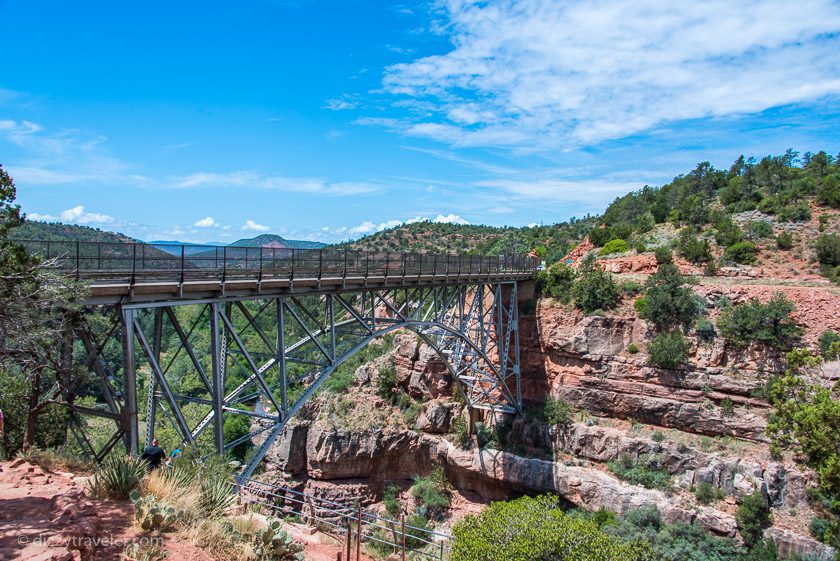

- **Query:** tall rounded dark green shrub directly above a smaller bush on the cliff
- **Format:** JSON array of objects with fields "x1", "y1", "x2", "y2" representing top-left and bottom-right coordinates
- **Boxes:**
[{"x1": 636, "y1": 263, "x2": 700, "y2": 329}]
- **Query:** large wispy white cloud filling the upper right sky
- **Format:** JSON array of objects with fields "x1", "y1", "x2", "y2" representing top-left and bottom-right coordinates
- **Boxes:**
[{"x1": 376, "y1": 0, "x2": 840, "y2": 149}]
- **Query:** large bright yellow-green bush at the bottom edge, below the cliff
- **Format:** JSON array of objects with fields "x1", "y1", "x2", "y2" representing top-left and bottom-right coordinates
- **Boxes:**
[{"x1": 451, "y1": 496, "x2": 650, "y2": 561}]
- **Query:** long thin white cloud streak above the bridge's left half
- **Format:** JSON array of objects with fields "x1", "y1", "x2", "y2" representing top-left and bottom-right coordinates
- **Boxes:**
[{"x1": 168, "y1": 171, "x2": 377, "y2": 196}]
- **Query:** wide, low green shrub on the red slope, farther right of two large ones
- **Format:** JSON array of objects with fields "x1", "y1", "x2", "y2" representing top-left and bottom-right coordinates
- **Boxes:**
[{"x1": 718, "y1": 292, "x2": 803, "y2": 349}]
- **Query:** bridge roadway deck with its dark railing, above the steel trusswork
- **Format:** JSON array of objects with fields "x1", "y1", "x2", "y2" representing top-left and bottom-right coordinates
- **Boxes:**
[{"x1": 21, "y1": 240, "x2": 536, "y2": 304}]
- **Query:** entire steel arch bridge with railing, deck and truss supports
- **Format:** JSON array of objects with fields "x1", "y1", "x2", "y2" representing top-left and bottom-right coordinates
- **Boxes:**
[{"x1": 23, "y1": 241, "x2": 535, "y2": 479}]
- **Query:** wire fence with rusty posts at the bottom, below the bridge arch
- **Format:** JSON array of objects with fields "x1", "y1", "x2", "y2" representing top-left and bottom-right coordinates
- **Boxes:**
[{"x1": 240, "y1": 479, "x2": 451, "y2": 561}]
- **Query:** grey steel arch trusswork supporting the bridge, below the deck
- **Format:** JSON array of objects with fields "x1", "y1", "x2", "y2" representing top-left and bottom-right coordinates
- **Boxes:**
[{"x1": 71, "y1": 281, "x2": 522, "y2": 480}]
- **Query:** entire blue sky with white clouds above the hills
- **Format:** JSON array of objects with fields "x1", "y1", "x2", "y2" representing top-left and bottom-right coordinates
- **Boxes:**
[{"x1": 0, "y1": 0, "x2": 840, "y2": 242}]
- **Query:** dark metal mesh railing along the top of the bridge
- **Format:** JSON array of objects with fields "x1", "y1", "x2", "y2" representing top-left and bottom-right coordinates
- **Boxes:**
[{"x1": 19, "y1": 240, "x2": 536, "y2": 283}]
